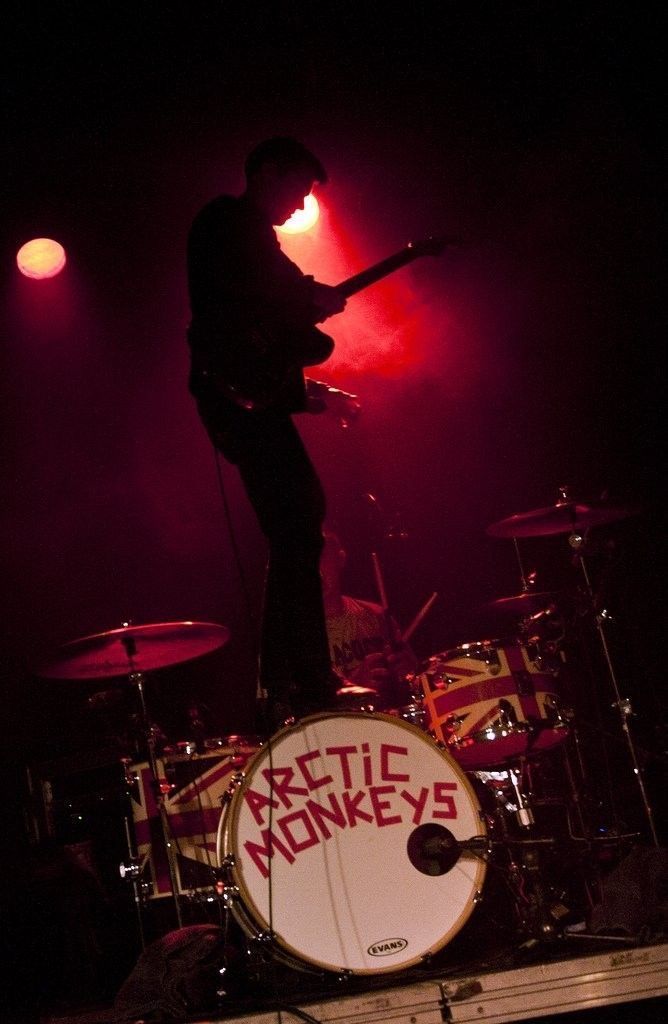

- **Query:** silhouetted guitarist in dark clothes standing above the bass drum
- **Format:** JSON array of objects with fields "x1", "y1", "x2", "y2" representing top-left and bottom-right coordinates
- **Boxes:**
[{"x1": 187, "y1": 137, "x2": 345, "y2": 728}]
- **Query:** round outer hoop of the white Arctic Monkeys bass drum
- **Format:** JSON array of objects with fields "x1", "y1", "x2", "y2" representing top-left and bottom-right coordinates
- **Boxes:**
[{"x1": 216, "y1": 710, "x2": 488, "y2": 976}]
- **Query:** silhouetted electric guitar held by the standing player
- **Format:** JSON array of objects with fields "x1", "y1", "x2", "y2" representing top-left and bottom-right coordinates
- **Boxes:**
[{"x1": 209, "y1": 237, "x2": 461, "y2": 411}]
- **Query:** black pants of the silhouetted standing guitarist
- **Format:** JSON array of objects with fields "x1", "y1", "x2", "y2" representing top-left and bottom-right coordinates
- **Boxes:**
[{"x1": 198, "y1": 398, "x2": 335, "y2": 715}]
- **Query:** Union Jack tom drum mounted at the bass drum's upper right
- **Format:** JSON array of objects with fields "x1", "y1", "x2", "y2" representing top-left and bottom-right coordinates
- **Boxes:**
[{"x1": 416, "y1": 640, "x2": 568, "y2": 769}]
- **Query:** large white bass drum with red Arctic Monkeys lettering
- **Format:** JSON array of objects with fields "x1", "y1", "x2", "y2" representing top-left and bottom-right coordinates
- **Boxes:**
[{"x1": 217, "y1": 712, "x2": 487, "y2": 975}]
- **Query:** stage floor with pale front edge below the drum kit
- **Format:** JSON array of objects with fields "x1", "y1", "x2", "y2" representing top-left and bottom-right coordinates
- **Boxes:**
[{"x1": 43, "y1": 935, "x2": 668, "y2": 1024}]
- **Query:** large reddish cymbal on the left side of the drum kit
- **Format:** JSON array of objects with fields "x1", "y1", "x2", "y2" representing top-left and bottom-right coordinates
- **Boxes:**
[{"x1": 35, "y1": 622, "x2": 229, "y2": 679}]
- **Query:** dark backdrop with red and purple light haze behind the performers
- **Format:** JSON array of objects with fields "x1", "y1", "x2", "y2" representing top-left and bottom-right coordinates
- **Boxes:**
[{"x1": 0, "y1": 2, "x2": 666, "y2": 1015}]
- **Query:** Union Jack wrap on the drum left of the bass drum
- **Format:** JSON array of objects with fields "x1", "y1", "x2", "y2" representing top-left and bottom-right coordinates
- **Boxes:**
[{"x1": 131, "y1": 743, "x2": 259, "y2": 899}]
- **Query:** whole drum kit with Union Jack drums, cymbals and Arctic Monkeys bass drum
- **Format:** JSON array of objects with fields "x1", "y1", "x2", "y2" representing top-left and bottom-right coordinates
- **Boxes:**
[{"x1": 37, "y1": 492, "x2": 656, "y2": 978}]
